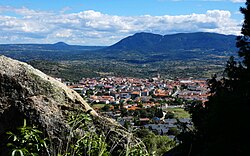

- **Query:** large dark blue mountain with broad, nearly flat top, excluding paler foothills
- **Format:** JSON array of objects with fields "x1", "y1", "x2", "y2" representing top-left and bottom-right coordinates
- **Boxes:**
[{"x1": 105, "y1": 32, "x2": 236, "y2": 52}]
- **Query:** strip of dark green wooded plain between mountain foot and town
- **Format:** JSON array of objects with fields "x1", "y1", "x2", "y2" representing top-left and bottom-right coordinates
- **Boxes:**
[{"x1": 28, "y1": 57, "x2": 226, "y2": 82}]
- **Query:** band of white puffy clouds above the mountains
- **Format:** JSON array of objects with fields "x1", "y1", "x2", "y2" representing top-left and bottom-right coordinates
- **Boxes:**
[{"x1": 0, "y1": 6, "x2": 240, "y2": 45}]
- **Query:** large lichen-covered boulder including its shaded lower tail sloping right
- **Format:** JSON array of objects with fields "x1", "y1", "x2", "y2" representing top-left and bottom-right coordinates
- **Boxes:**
[{"x1": 0, "y1": 56, "x2": 145, "y2": 154}]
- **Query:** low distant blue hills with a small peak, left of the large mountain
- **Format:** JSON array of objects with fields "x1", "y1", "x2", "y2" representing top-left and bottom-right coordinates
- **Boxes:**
[{"x1": 0, "y1": 42, "x2": 104, "y2": 61}]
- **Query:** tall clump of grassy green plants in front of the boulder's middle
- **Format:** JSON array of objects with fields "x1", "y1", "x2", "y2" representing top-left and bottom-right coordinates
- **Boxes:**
[{"x1": 63, "y1": 111, "x2": 110, "y2": 156}]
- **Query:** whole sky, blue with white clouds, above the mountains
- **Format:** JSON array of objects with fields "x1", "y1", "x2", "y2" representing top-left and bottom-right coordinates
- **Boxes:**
[{"x1": 0, "y1": 0, "x2": 245, "y2": 46}]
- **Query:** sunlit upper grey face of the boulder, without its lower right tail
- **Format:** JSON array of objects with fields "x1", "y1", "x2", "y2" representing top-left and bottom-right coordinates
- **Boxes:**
[{"x1": 0, "y1": 56, "x2": 98, "y2": 138}]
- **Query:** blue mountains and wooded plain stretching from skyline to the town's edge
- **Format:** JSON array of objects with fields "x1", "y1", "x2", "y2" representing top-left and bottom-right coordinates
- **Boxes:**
[{"x1": 0, "y1": 32, "x2": 237, "y2": 81}]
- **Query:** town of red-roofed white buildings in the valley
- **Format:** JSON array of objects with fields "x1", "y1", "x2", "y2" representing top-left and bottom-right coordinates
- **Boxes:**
[{"x1": 65, "y1": 75, "x2": 209, "y2": 138}]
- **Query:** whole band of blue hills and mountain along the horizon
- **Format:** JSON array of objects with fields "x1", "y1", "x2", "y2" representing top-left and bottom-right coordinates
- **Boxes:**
[{"x1": 0, "y1": 32, "x2": 236, "y2": 63}]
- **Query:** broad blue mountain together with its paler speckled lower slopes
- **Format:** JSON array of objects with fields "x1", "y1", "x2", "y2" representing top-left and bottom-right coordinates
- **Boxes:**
[{"x1": 102, "y1": 32, "x2": 237, "y2": 63}]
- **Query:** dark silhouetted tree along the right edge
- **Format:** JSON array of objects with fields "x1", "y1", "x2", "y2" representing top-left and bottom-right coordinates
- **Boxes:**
[{"x1": 169, "y1": 0, "x2": 250, "y2": 156}]
